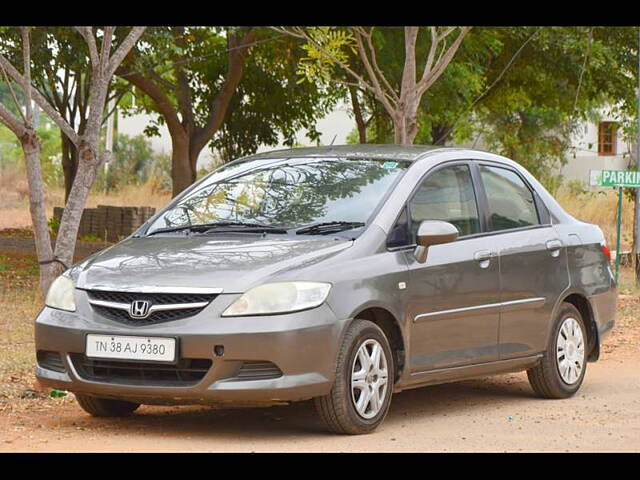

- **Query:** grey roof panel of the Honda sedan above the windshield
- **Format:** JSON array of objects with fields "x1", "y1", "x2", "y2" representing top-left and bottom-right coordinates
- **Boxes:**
[{"x1": 242, "y1": 144, "x2": 464, "y2": 161}]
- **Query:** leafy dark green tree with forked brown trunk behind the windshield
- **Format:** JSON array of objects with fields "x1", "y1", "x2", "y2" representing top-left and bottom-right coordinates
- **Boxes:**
[{"x1": 117, "y1": 27, "x2": 340, "y2": 196}]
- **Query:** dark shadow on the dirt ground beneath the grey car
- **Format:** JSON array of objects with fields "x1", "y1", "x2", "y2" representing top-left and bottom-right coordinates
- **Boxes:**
[{"x1": 48, "y1": 375, "x2": 533, "y2": 441}]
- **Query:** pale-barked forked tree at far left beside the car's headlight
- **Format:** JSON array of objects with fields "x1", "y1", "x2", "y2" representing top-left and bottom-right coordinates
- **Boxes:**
[{"x1": 0, "y1": 27, "x2": 144, "y2": 294}]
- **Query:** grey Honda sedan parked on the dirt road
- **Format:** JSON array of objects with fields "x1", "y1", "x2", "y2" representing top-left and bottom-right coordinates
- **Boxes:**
[{"x1": 35, "y1": 145, "x2": 616, "y2": 434}]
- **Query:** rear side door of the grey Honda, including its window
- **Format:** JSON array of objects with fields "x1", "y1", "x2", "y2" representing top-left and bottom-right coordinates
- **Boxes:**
[{"x1": 478, "y1": 163, "x2": 569, "y2": 360}]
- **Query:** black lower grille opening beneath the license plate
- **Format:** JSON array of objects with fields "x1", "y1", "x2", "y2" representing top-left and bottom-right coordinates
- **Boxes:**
[{"x1": 71, "y1": 354, "x2": 213, "y2": 387}]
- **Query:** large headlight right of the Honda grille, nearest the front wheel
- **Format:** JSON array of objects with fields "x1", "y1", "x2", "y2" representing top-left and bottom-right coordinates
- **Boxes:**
[{"x1": 222, "y1": 282, "x2": 331, "y2": 317}]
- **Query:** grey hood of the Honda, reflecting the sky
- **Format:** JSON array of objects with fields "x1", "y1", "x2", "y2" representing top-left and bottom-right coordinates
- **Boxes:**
[{"x1": 77, "y1": 234, "x2": 353, "y2": 293}]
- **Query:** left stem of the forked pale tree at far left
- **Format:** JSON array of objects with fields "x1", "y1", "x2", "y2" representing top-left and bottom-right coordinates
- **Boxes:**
[{"x1": 20, "y1": 130, "x2": 60, "y2": 296}]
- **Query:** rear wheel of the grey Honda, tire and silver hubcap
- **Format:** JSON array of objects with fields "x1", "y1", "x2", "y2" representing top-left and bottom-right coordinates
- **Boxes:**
[{"x1": 527, "y1": 303, "x2": 588, "y2": 398}]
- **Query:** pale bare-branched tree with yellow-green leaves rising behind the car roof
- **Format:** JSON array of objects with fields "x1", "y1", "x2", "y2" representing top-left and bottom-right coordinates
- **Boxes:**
[{"x1": 276, "y1": 27, "x2": 471, "y2": 145}]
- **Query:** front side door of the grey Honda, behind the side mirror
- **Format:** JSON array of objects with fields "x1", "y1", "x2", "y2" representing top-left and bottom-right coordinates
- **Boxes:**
[{"x1": 405, "y1": 162, "x2": 500, "y2": 374}]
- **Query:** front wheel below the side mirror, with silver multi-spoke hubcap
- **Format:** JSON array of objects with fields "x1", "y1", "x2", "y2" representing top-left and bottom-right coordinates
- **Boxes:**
[{"x1": 314, "y1": 319, "x2": 395, "y2": 435}]
